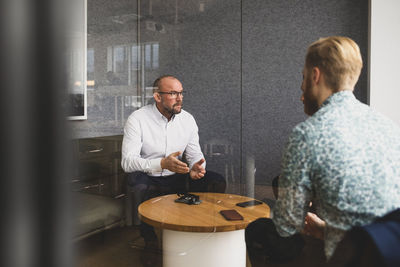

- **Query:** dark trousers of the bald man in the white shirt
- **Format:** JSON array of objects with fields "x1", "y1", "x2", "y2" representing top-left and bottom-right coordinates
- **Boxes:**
[{"x1": 127, "y1": 171, "x2": 226, "y2": 242}]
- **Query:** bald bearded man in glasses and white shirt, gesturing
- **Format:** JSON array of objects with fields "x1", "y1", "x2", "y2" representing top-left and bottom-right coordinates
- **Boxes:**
[{"x1": 121, "y1": 75, "x2": 226, "y2": 264}]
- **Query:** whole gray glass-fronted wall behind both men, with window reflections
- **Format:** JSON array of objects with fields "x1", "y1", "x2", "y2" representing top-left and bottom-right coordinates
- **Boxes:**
[{"x1": 75, "y1": 0, "x2": 368, "y2": 199}]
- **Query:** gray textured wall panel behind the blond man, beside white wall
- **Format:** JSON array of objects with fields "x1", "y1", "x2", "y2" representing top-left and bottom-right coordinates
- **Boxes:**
[{"x1": 242, "y1": 0, "x2": 368, "y2": 183}]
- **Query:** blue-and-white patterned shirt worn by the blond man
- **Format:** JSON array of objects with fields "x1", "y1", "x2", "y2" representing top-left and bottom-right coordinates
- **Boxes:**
[{"x1": 273, "y1": 91, "x2": 400, "y2": 259}]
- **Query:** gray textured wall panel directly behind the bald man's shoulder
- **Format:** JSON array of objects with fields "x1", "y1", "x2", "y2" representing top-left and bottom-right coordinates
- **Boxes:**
[{"x1": 141, "y1": 0, "x2": 241, "y2": 193}]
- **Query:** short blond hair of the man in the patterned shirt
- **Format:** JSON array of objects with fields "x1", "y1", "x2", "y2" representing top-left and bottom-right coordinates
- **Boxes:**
[{"x1": 305, "y1": 36, "x2": 363, "y2": 92}]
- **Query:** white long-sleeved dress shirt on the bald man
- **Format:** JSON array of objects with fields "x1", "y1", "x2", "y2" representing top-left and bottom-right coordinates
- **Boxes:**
[{"x1": 121, "y1": 104, "x2": 205, "y2": 176}]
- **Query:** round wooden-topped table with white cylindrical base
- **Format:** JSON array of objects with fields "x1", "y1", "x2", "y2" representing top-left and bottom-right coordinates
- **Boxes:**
[{"x1": 139, "y1": 193, "x2": 270, "y2": 267}]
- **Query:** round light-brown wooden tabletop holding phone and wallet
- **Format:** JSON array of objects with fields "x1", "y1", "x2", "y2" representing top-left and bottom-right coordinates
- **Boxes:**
[{"x1": 139, "y1": 193, "x2": 270, "y2": 232}]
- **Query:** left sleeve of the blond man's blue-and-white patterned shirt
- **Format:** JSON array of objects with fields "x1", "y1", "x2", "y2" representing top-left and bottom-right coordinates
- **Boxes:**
[{"x1": 273, "y1": 127, "x2": 312, "y2": 236}]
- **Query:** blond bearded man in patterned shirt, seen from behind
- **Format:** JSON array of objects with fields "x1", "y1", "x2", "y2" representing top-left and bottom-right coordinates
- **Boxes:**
[{"x1": 246, "y1": 37, "x2": 400, "y2": 263}]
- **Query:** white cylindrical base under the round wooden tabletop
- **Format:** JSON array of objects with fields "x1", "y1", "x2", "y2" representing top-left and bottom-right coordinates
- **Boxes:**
[{"x1": 163, "y1": 229, "x2": 246, "y2": 267}]
